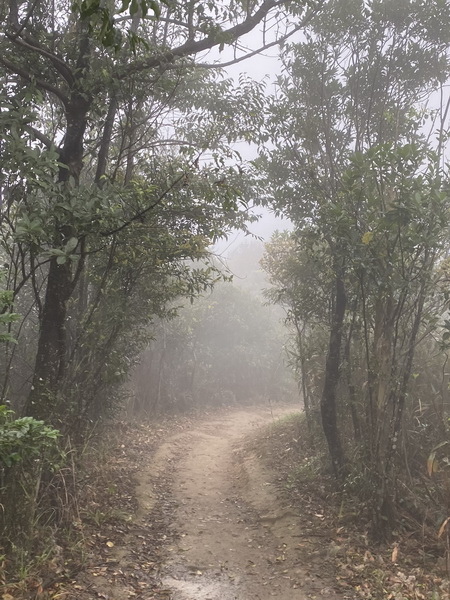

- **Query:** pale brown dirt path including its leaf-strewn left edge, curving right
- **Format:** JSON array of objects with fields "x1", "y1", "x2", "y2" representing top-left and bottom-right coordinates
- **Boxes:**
[{"x1": 65, "y1": 406, "x2": 342, "y2": 600}]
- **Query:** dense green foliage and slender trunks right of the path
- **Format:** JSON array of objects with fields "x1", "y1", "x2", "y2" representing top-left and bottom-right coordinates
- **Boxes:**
[{"x1": 260, "y1": 1, "x2": 450, "y2": 535}]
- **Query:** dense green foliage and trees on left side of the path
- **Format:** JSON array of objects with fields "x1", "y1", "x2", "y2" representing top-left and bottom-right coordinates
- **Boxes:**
[{"x1": 0, "y1": 0, "x2": 312, "y2": 576}]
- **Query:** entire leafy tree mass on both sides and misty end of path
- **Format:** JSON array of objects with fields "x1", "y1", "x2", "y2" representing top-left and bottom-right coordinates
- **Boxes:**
[{"x1": 0, "y1": 0, "x2": 450, "y2": 592}]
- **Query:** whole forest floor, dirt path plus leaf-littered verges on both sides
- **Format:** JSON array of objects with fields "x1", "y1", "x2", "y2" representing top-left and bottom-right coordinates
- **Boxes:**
[{"x1": 9, "y1": 404, "x2": 450, "y2": 600}]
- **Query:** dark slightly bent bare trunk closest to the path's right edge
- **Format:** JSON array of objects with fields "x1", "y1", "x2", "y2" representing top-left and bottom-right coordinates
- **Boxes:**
[{"x1": 320, "y1": 266, "x2": 347, "y2": 478}]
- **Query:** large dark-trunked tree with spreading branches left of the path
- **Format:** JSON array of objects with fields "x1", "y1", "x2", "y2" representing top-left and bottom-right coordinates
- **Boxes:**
[{"x1": 0, "y1": 0, "x2": 316, "y2": 426}]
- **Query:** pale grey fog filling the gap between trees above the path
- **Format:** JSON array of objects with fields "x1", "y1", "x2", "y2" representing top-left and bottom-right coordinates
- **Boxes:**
[{"x1": 130, "y1": 236, "x2": 298, "y2": 413}]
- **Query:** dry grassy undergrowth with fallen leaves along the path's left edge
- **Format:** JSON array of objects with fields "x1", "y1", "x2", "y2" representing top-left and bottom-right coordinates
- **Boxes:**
[{"x1": 0, "y1": 423, "x2": 151, "y2": 600}]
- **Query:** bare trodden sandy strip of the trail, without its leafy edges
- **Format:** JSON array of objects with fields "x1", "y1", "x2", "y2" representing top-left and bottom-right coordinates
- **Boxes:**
[{"x1": 149, "y1": 407, "x2": 337, "y2": 600}]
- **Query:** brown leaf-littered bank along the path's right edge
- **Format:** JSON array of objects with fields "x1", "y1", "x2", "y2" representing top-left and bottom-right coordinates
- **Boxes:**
[{"x1": 251, "y1": 413, "x2": 450, "y2": 600}]
